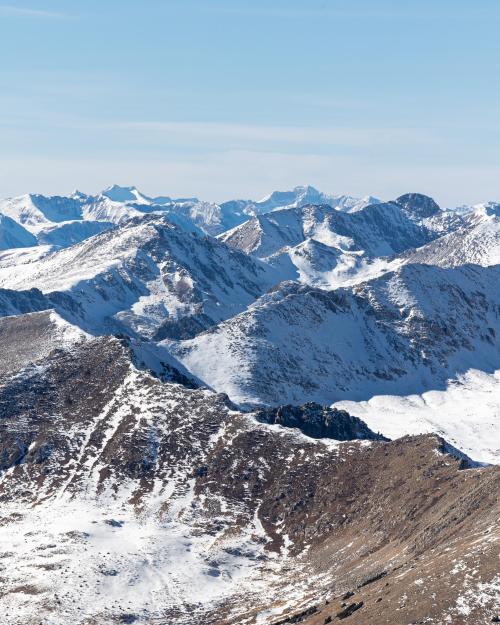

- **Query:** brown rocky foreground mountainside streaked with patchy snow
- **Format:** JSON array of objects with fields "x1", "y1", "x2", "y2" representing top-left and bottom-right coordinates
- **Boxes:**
[{"x1": 0, "y1": 312, "x2": 500, "y2": 625}]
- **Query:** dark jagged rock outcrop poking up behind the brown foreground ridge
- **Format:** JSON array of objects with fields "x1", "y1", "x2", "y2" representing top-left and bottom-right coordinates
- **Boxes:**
[{"x1": 255, "y1": 402, "x2": 388, "y2": 441}]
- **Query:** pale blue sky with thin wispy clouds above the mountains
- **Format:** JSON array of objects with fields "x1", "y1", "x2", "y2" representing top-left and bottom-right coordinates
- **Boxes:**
[{"x1": 0, "y1": 0, "x2": 500, "y2": 206}]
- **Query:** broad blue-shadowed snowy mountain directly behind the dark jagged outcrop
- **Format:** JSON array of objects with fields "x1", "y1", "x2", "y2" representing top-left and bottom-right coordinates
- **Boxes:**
[{"x1": 169, "y1": 265, "x2": 500, "y2": 453}]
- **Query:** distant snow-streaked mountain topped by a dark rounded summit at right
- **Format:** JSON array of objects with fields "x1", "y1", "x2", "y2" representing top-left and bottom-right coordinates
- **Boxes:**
[{"x1": 219, "y1": 193, "x2": 476, "y2": 289}]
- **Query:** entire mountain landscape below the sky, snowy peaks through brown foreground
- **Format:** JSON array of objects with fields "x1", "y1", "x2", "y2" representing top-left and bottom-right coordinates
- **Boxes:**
[{"x1": 0, "y1": 185, "x2": 500, "y2": 625}]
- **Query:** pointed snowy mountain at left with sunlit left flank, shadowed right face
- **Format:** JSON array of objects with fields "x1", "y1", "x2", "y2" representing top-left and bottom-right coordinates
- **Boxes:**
[{"x1": 0, "y1": 215, "x2": 278, "y2": 338}]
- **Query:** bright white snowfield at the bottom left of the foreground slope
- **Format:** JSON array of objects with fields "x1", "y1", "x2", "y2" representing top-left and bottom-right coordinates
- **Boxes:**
[{"x1": 0, "y1": 489, "x2": 274, "y2": 625}]
